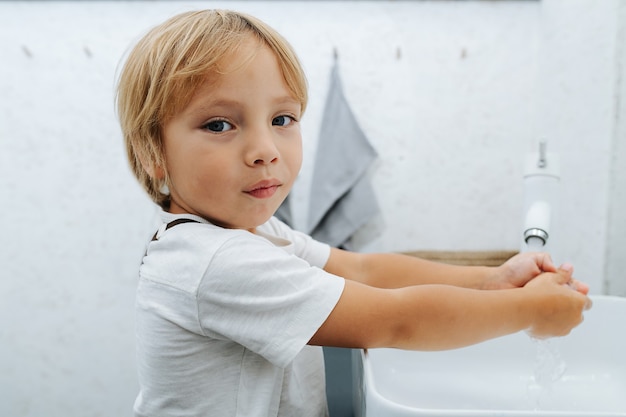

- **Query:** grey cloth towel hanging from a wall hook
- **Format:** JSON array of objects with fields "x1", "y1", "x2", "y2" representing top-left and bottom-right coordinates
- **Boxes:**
[{"x1": 308, "y1": 57, "x2": 380, "y2": 249}]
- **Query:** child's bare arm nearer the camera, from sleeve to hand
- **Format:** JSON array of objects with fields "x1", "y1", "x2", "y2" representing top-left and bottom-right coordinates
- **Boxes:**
[{"x1": 309, "y1": 268, "x2": 590, "y2": 350}]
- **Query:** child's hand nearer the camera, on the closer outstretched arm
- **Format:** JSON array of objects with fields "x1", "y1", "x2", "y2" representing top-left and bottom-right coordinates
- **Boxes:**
[{"x1": 524, "y1": 265, "x2": 591, "y2": 339}]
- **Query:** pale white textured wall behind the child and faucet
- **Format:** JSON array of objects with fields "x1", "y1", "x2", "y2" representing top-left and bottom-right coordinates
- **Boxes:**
[{"x1": 0, "y1": 0, "x2": 626, "y2": 417}]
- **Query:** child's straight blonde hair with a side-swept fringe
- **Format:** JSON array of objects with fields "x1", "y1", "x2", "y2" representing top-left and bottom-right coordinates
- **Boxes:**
[{"x1": 117, "y1": 10, "x2": 307, "y2": 208}]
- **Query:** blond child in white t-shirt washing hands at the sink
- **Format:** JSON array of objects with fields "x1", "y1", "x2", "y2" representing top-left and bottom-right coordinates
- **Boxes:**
[{"x1": 118, "y1": 10, "x2": 589, "y2": 417}]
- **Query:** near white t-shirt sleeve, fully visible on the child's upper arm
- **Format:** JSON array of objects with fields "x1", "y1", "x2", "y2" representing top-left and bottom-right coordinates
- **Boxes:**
[{"x1": 197, "y1": 232, "x2": 344, "y2": 367}]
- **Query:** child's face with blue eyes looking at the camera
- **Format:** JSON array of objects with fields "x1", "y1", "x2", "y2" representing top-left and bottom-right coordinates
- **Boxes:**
[{"x1": 163, "y1": 38, "x2": 302, "y2": 232}]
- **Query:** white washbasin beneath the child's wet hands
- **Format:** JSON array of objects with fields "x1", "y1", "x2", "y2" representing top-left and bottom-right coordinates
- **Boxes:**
[{"x1": 353, "y1": 296, "x2": 626, "y2": 417}]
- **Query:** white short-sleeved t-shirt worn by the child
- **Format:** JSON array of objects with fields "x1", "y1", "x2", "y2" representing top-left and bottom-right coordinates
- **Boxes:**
[{"x1": 135, "y1": 213, "x2": 344, "y2": 417}]
